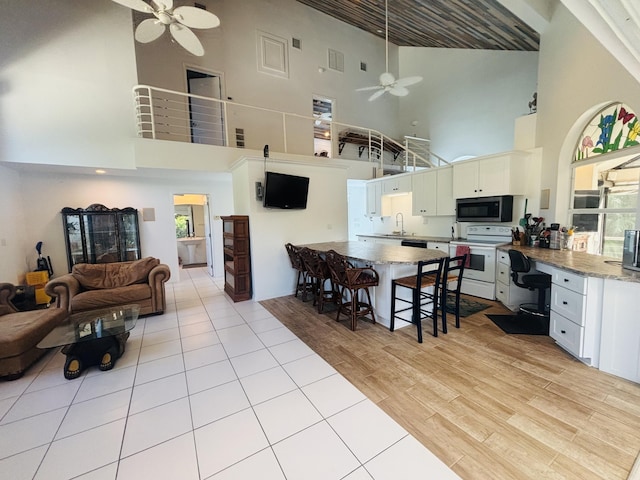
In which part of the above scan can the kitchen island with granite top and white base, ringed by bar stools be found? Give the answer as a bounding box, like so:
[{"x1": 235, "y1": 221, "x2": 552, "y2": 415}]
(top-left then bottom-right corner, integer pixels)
[{"x1": 301, "y1": 242, "x2": 448, "y2": 328}]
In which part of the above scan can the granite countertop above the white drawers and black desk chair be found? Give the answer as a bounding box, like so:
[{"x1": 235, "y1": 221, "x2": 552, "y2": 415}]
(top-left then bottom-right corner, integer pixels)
[{"x1": 498, "y1": 245, "x2": 640, "y2": 283}]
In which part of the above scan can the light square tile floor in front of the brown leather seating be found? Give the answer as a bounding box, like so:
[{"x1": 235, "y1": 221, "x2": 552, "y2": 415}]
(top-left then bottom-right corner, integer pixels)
[{"x1": 0, "y1": 269, "x2": 458, "y2": 480}]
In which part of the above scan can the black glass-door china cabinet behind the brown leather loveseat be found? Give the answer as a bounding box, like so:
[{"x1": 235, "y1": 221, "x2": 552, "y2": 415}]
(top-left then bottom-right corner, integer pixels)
[{"x1": 62, "y1": 203, "x2": 141, "y2": 271}]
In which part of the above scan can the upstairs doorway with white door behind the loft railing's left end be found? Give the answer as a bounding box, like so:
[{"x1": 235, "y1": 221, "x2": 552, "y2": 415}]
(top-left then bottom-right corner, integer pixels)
[{"x1": 186, "y1": 68, "x2": 225, "y2": 146}]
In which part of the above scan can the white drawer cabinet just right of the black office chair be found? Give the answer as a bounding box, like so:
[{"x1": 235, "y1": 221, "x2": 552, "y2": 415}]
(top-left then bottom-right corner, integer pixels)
[{"x1": 549, "y1": 268, "x2": 603, "y2": 367}]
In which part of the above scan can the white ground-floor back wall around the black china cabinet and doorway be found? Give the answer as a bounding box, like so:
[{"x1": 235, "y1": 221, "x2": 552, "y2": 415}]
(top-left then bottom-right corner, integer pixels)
[{"x1": 10, "y1": 172, "x2": 233, "y2": 280}]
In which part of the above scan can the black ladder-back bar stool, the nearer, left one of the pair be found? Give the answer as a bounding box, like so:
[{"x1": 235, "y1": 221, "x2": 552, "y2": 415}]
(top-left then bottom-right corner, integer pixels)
[{"x1": 389, "y1": 257, "x2": 447, "y2": 343}]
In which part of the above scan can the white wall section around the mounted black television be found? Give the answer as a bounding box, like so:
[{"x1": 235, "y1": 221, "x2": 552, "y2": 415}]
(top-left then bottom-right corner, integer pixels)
[{"x1": 233, "y1": 159, "x2": 348, "y2": 300}]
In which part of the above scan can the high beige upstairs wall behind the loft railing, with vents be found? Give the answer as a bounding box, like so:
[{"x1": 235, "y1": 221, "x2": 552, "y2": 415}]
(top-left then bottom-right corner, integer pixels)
[{"x1": 135, "y1": 0, "x2": 398, "y2": 139}]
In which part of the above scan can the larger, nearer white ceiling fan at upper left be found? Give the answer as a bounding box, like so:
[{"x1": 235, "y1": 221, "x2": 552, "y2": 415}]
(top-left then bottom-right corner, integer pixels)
[{"x1": 113, "y1": 0, "x2": 220, "y2": 57}]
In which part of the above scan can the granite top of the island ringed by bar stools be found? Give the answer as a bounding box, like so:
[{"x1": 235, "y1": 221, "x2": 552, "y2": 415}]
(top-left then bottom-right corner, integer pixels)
[{"x1": 300, "y1": 242, "x2": 448, "y2": 265}]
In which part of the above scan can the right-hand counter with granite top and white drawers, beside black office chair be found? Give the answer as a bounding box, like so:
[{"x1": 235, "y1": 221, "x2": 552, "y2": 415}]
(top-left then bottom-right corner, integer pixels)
[{"x1": 498, "y1": 245, "x2": 640, "y2": 382}]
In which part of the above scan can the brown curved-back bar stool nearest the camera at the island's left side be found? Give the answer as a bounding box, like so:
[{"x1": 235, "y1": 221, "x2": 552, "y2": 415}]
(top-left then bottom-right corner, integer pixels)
[{"x1": 325, "y1": 250, "x2": 379, "y2": 330}]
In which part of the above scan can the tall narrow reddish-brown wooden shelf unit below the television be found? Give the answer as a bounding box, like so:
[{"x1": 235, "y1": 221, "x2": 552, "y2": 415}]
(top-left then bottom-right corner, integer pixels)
[{"x1": 221, "y1": 215, "x2": 252, "y2": 302}]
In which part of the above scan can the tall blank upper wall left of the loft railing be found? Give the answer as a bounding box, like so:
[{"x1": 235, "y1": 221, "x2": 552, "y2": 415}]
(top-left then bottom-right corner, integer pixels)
[{"x1": 0, "y1": 0, "x2": 137, "y2": 168}]
